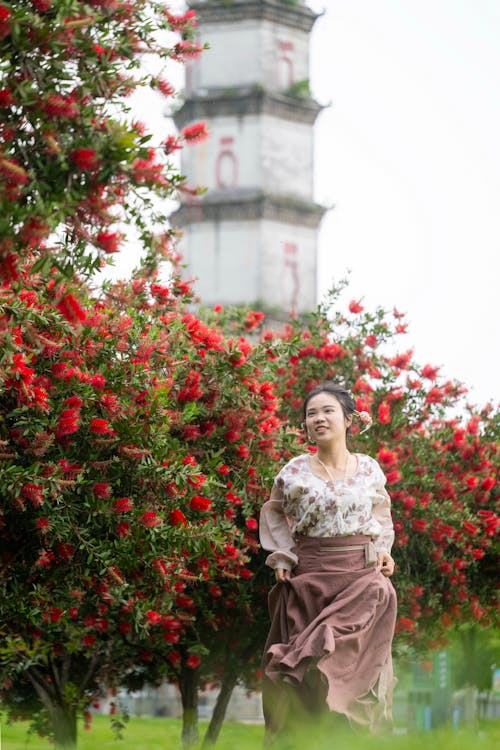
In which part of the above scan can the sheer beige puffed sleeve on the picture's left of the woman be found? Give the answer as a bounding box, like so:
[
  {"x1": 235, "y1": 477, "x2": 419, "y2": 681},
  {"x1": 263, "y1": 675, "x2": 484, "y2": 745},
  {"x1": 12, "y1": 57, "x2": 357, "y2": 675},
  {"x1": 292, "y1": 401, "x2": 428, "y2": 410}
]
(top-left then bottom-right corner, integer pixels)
[{"x1": 259, "y1": 480, "x2": 298, "y2": 570}]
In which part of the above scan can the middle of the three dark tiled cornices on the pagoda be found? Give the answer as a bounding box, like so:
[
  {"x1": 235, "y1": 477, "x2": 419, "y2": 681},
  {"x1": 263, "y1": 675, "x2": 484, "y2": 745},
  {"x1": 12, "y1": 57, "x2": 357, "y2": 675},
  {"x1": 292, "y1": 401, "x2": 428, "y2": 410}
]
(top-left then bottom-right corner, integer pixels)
[{"x1": 174, "y1": 86, "x2": 323, "y2": 128}]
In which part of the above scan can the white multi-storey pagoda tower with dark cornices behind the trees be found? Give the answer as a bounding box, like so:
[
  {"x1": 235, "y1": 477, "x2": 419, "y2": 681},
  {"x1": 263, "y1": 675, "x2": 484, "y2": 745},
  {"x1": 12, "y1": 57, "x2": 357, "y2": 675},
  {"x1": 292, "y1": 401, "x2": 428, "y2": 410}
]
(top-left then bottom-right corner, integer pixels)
[{"x1": 172, "y1": 0, "x2": 324, "y2": 317}]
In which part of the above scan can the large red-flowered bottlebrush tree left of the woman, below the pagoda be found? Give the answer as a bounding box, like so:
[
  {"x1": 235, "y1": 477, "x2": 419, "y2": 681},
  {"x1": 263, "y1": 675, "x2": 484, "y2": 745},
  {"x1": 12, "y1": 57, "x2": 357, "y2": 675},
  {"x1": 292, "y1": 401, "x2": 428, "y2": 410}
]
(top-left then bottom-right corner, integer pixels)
[{"x1": 0, "y1": 267, "x2": 296, "y2": 747}]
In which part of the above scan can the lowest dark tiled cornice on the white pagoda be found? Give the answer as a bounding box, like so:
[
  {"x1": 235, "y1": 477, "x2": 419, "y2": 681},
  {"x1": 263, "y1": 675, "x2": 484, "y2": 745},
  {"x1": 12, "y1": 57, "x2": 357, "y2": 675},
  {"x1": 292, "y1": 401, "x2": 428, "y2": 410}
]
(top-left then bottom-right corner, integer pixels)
[{"x1": 170, "y1": 189, "x2": 328, "y2": 229}]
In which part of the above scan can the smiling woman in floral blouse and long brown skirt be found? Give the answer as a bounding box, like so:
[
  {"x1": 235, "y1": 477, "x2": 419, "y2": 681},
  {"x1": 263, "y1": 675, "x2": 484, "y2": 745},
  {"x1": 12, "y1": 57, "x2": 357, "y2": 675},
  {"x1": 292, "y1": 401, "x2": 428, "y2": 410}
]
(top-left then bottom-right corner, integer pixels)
[{"x1": 260, "y1": 383, "x2": 396, "y2": 739}]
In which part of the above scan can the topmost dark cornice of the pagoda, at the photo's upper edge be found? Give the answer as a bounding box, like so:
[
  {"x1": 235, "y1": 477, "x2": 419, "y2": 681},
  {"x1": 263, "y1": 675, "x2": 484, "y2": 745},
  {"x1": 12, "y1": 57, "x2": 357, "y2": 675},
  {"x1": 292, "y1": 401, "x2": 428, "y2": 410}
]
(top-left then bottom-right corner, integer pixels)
[{"x1": 189, "y1": 0, "x2": 318, "y2": 33}]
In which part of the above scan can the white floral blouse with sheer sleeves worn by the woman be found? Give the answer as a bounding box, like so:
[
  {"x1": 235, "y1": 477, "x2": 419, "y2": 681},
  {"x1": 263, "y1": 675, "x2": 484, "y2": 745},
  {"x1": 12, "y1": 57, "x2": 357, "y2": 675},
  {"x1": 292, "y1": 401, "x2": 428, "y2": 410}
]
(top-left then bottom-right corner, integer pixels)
[{"x1": 260, "y1": 453, "x2": 394, "y2": 570}]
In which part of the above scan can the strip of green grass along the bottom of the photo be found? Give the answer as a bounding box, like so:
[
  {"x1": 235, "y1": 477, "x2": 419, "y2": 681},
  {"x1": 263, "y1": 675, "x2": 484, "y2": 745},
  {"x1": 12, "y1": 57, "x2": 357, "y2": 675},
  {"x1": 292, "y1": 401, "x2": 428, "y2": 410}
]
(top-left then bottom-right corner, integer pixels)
[{"x1": 1, "y1": 716, "x2": 500, "y2": 750}]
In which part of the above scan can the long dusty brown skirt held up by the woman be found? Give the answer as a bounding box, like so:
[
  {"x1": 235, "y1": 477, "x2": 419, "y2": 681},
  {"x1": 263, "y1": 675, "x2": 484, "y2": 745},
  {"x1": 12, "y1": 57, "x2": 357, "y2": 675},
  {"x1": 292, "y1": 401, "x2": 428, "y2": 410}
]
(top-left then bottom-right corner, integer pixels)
[{"x1": 263, "y1": 536, "x2": 396, "y2": 732}]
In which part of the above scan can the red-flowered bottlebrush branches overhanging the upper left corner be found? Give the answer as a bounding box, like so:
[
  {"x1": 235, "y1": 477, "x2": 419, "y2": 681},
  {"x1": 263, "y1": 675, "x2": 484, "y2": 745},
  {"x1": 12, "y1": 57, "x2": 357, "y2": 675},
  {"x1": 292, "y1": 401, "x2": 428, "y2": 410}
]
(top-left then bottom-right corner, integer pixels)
[{"x1": 0, "y1": 0, "x2": 205, "y2": 284}]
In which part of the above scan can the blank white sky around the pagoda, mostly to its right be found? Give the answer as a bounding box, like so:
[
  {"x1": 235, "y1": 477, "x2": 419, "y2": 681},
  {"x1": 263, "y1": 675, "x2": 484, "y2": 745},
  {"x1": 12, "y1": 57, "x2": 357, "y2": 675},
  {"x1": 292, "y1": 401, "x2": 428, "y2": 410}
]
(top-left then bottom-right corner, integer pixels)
[{"x1": 122, "y1": 0, "x2": 500, "y2": 404}]
